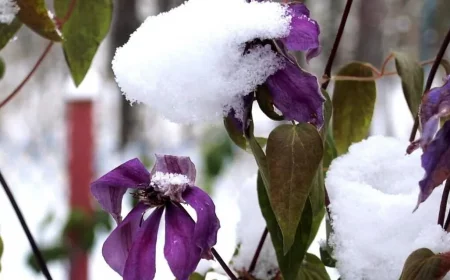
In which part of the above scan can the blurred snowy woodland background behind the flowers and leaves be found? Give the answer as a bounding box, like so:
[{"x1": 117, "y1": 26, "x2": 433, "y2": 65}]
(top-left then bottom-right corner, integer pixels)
[{"x1": 0, "y1": 0, "x2": 450, "y2": 280}]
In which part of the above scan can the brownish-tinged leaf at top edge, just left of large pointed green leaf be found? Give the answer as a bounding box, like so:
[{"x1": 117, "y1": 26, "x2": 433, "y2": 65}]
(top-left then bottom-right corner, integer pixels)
[{"x1": 16, "y1": 0, "x2": 62, "y2": 42}]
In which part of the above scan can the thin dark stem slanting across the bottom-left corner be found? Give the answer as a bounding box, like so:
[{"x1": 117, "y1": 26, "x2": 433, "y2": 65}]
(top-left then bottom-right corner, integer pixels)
[{"x1": 0, "y1": 171, "x2": 52, "y2": 280}]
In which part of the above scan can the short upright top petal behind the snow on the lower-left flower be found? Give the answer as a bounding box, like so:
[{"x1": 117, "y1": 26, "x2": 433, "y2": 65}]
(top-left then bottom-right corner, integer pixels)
[{"x1": 151, "y1": 154, "x2": 196, "y2": 184}]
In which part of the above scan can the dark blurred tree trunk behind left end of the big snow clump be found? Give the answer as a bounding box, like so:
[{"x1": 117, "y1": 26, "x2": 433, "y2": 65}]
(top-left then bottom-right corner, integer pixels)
[{"x1": 110, "y1": 0, "x2": 140, "y2": 148}]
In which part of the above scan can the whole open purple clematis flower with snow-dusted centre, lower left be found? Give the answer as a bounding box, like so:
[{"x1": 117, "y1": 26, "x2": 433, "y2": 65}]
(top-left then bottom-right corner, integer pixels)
[{"x1": 91, "y1": 155, "x2": 220, "y2": 280}]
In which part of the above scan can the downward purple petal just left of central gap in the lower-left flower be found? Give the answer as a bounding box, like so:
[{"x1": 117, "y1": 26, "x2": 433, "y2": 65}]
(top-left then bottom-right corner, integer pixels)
[{"x1": 123, "y1": 207, "x2": 164, "y2": 280}]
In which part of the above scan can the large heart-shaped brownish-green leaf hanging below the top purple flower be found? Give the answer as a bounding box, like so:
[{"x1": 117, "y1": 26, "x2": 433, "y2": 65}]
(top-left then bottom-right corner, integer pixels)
[{"x1": 266, "y1": 123, "x2": 323, "y2": 253}]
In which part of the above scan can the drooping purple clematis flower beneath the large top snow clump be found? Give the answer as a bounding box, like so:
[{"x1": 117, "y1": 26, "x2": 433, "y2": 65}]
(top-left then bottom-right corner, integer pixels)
[{"x1": 228, "y1": 3, "x2": 325, "y2": 131}]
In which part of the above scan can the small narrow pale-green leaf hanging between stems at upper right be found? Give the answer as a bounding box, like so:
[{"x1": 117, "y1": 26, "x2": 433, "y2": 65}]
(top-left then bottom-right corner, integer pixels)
[{"x1": 394, "y1": 52, "x2": 424, "y2": 117}]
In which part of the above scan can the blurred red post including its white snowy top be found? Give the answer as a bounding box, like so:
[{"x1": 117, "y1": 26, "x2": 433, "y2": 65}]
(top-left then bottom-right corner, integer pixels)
[{"x1": 66, "y1": 73, "x2": 99, "y2": 280}]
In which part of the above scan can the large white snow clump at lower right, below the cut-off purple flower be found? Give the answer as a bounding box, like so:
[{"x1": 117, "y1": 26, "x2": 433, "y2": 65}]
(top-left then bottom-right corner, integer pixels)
[{"x1": 326, "y1": 136, "x2": 450, "y2": 280}]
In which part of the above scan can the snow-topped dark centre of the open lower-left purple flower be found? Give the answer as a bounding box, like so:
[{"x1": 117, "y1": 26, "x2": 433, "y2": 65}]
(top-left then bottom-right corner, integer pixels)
[{"x1": 133, "y1": 172, "x2": 191, "y2": 207}]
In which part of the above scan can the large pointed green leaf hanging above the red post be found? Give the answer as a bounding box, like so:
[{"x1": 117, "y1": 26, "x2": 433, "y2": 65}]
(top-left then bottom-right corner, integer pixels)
[{"x1": 55, "y1": 0, "x2": 113, "y2": 86}]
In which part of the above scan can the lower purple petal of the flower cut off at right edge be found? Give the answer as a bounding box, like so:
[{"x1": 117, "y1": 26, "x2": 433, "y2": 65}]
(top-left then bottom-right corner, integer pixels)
[{"x1": 419, "y1": 121, "x2": 450, "y2": 207}]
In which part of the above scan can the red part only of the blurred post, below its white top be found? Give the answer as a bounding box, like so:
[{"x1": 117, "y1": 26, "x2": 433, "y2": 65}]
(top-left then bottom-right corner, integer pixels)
[{"x1": 67, "y1": 98, "x2": 94, "y2": 280}]
